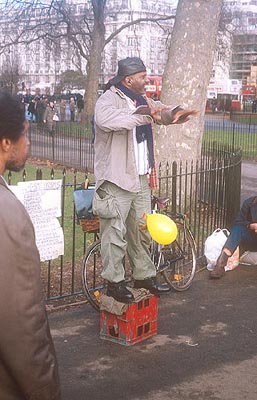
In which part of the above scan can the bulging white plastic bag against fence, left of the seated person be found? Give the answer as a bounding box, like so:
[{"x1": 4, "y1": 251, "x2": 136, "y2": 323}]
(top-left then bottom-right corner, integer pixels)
[{"x1": 204, "y1": 228, "x2": 229, "y2": 271}]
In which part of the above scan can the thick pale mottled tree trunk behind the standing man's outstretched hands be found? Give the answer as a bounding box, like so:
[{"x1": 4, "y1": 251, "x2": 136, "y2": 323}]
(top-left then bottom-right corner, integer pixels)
[{"x1": 155, "y1": 0, "x2": 222, "y2": 163}]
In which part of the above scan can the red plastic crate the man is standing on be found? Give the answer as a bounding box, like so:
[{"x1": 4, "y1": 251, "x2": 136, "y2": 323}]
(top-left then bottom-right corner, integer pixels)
[{"x1": 100, "y1": 296, "x2": 158, "y2": 346}]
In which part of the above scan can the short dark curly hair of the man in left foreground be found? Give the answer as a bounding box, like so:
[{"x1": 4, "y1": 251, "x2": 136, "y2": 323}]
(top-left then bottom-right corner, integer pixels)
[{"x1": 0, "y1": 92, "x2": 25, "y2": 142}]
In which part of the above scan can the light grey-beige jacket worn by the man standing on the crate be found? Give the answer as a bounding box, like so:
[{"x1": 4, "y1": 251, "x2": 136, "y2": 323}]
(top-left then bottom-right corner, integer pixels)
[{"x1": 94, "y1": 86, "x2": 177, "y2": 192}]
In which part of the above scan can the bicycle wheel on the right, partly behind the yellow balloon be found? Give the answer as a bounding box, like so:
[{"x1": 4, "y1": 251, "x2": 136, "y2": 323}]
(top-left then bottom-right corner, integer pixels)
[{"x1": 161, "y1": 221, "x2": 196, "y2": 291}]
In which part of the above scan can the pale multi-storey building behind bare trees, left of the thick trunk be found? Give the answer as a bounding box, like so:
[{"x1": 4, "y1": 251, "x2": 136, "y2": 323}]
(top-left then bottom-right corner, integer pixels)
[{"x1": 0, "y1": 0, "x2": 177, "y2": 94}]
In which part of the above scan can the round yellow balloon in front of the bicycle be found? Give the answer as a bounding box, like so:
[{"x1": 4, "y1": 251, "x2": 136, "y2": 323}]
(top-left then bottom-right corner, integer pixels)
[{"x1": 146, "y1": 214, "x2": 178, "y2": 244}]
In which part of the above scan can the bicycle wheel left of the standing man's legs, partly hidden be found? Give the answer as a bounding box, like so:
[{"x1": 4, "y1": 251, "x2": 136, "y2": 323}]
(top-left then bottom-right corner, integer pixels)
[{"x1": 82, "y1": 240, "x2": 104, "y2": 311}]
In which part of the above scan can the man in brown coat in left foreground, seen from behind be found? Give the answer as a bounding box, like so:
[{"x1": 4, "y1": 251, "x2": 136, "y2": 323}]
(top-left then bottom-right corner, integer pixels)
[{"x1": 0, "y1": 92, "x2": 61, "y2": 400}]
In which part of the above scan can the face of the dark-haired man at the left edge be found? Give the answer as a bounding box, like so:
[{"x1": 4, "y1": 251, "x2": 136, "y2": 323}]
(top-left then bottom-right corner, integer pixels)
[{"x1": 5, "y1": 121, "x2": 29, "y2": 172}]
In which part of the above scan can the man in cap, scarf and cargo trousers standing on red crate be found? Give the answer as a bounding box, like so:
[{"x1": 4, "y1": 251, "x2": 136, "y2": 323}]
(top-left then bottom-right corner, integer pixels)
[{"x1": 93, "y1": 57, "x2": 196, "y2": 303}]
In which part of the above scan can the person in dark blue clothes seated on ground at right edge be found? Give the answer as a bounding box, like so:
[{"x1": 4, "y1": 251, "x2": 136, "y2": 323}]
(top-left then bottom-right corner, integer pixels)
[{"x1": 210, "y1": 196, "x2": 257, "y2": 279}]
